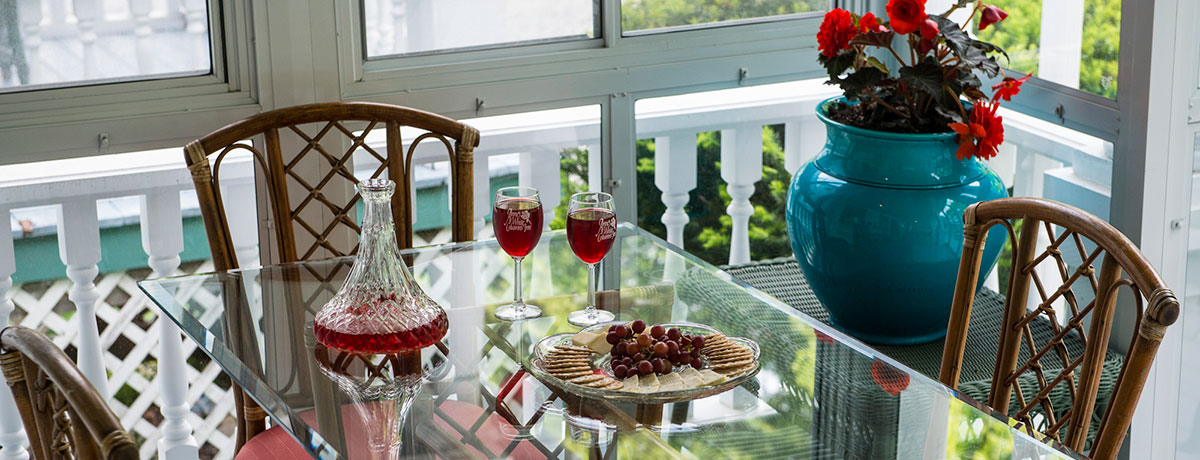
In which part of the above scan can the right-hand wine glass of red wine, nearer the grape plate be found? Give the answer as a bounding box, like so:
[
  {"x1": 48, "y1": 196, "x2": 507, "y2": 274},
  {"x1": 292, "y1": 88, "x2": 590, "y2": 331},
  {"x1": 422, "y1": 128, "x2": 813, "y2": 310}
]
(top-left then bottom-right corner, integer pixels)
[{"x1": 566, "y1": 192, "x2": 617, "y2": 327}]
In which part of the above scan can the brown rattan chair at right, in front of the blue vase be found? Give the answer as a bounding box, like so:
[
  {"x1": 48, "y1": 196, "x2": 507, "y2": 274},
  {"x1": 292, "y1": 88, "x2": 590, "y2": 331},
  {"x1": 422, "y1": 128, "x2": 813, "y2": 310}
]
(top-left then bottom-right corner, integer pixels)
[{"x1": 940, "y1": 198, "x2": 1180, "y2": 459}]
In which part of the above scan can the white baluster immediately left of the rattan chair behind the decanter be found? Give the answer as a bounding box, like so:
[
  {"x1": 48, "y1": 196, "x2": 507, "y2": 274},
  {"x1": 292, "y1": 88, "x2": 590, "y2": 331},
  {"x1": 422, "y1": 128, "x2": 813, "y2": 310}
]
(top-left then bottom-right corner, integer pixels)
[{"x1": 142, "y1": 191, "x2": 200, "y2": 460}]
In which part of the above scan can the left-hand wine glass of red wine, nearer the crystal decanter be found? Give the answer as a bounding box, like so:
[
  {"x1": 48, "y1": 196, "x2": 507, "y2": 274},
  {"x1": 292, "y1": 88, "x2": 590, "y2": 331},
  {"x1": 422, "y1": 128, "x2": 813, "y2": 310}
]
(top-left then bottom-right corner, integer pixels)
[{"x1": 492, "y1": 187, "x2": 542, "y2": 321}]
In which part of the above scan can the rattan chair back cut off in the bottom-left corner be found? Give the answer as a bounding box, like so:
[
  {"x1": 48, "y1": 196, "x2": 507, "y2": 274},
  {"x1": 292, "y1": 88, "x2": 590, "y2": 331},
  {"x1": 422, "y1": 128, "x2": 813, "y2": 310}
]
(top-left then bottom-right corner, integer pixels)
[{"x1": 0, "y1": 325, "x2": 138, "y2": 460}]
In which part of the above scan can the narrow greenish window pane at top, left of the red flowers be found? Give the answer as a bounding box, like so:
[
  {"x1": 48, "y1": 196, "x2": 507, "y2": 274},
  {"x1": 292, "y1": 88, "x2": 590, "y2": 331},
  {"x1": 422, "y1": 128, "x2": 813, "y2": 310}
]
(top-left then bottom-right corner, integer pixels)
[{"x1": 620, "y1": 0, "x2": 830, "y2": 32}]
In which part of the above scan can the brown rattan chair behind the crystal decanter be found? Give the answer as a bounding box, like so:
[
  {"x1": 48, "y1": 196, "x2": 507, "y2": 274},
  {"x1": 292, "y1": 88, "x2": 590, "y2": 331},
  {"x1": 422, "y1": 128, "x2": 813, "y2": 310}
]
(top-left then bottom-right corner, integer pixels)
[{"x1": 184, "y1": 102, "x2": 479, "y2": 449}]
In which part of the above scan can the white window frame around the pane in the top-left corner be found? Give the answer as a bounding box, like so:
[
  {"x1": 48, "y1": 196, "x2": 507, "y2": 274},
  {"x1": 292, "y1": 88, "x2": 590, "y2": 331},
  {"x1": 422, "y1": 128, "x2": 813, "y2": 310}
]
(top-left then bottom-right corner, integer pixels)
[{"x1": 0, "y1": 0, "x2": 260, "y2": 165}]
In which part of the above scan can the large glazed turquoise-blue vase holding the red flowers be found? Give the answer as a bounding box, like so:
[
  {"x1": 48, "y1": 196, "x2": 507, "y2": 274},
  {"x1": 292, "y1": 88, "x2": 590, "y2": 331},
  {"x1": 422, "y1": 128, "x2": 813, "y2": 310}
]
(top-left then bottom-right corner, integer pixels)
[{"x1": 787, "y1": 97, "x2": 1008, "y2": 345}]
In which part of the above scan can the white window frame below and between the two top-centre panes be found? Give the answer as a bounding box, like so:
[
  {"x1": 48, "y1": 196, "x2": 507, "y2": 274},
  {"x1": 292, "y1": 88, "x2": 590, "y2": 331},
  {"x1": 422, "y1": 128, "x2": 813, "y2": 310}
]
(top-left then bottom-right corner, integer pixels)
[{"x1": 334, "y1": 0, "x2": 844, "y2": 221}]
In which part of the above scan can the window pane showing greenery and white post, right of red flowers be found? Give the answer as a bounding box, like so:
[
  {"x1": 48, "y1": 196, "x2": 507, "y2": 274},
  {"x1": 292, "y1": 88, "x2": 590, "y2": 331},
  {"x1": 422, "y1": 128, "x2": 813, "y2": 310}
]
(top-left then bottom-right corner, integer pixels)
[{"x1": 979, "y1": 0, "x2": 1121, "y2": 98}]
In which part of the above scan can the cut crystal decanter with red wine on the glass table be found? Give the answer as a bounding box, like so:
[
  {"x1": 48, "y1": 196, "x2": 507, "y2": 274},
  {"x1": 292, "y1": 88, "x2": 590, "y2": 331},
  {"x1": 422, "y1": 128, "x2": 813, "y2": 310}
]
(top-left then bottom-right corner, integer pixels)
[{"x1": 313, "y1": 179, "x2": 449, "y2": 353}]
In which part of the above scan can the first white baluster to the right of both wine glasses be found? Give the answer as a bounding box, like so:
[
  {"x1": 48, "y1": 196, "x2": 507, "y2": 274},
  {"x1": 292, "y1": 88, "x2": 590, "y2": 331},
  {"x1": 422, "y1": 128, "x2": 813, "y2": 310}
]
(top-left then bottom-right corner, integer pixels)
[{"x1": 654, "y1": 132, "x2": 696, "y2": 247}]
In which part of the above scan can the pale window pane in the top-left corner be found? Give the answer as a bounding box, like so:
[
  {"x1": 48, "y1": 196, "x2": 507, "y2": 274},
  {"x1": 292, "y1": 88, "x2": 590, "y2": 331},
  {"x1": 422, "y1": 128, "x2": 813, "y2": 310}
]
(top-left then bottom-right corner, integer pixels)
[{"x1": 0, "y1": 0, "x2": 212, "y2": 92}]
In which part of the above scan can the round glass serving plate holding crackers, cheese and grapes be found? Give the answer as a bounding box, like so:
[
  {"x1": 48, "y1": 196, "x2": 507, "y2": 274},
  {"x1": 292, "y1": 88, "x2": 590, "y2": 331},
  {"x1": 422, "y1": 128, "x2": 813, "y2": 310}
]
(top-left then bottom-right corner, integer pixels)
[{"x1": 526, "y1": 321, "x2": 762, "y2": 404}]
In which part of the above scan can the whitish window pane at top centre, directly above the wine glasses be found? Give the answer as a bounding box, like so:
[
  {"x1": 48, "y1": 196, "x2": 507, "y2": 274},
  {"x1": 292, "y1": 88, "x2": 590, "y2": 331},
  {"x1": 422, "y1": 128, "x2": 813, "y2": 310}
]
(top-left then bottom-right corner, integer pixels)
[{"x1": 362, "y1": 0, "x2": 600, "y2": 58}]
